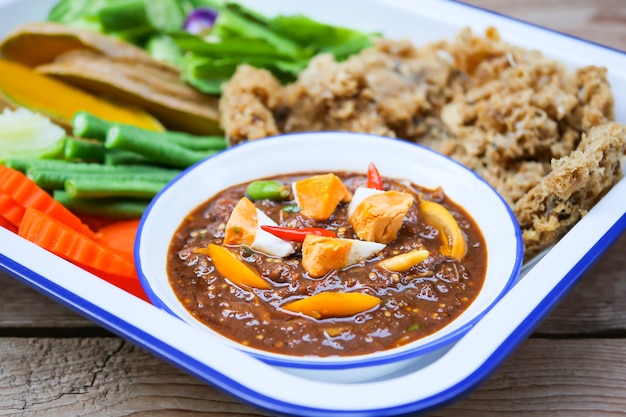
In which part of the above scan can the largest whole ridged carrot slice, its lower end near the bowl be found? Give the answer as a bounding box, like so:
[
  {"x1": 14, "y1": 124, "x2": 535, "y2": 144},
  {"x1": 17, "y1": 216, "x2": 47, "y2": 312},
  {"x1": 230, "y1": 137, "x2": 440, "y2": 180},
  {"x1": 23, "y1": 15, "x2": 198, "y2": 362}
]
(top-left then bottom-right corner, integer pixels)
[{"x1": 18, "y1": 207, "x2": 136, "y2": 278}]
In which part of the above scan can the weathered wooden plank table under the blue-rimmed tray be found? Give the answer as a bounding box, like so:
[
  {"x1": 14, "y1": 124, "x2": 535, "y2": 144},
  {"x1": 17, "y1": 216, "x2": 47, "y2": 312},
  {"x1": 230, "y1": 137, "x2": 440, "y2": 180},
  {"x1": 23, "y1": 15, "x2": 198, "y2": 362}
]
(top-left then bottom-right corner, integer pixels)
[{"x1": 0, "y1": 0, "x2": 626, "y2": 417}]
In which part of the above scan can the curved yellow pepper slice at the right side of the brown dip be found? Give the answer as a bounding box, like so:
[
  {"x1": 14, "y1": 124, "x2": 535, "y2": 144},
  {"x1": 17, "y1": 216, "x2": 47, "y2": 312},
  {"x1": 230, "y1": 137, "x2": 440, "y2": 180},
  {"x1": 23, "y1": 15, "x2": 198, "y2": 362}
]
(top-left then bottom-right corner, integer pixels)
[{"x1": 420, "y1": 199, "x2": 467, "y2": 260}]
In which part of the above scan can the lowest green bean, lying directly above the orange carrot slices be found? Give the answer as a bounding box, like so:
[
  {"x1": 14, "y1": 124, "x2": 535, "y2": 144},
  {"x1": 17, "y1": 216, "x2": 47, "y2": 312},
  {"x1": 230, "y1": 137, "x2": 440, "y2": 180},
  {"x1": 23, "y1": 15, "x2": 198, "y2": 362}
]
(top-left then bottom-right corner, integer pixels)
[{"x1": 53, "y1": 190, "x2": 150, "y2": 219}]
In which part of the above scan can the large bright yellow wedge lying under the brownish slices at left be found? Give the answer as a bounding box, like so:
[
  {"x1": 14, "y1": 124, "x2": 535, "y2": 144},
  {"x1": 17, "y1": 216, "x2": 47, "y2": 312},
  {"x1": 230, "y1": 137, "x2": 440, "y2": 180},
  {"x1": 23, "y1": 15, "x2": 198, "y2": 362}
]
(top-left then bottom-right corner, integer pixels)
[{"x1": 0, "y1": 59, "x2": 163, "y2": 130}]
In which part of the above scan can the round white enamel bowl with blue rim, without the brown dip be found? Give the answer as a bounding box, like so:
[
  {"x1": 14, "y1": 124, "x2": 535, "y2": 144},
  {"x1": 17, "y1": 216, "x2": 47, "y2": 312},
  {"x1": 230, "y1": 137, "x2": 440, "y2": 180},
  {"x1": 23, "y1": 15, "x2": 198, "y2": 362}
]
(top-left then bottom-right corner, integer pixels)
[{"x1": 135, "y1": 132, "x2": 523, "y2": 382}]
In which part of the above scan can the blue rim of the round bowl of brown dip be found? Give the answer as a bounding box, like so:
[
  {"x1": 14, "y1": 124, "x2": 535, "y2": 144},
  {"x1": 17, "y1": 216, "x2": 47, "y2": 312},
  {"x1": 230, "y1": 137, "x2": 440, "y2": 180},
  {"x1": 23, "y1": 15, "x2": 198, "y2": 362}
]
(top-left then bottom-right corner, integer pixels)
[{"x1": 134, "y1": 131, "x2": 524, "y2": 370}]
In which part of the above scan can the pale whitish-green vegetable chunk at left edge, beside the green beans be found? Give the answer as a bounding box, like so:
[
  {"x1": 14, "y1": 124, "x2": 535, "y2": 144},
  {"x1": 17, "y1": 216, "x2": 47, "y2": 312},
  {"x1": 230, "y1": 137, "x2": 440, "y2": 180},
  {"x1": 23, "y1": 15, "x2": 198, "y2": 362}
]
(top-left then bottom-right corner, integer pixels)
[{"x1": 0, "y1": 107, "x2": 65, "y2": 161}]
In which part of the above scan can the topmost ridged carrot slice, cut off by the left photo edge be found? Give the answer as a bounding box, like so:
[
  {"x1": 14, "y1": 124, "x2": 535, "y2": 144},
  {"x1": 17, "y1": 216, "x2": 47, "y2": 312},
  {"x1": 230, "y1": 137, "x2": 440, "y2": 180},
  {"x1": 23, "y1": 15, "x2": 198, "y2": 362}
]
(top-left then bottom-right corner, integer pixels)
[{"x1": 0, "y1": 165, "x2": 95, "y2": 238}]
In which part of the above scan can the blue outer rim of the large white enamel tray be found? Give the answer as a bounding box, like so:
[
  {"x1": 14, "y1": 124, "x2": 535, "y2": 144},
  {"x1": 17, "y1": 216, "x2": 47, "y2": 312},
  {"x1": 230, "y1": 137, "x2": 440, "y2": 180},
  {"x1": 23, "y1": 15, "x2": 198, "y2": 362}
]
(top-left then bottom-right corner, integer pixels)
[{"x1": 0, "y1": 0, "x2": 626, "y2": 417}]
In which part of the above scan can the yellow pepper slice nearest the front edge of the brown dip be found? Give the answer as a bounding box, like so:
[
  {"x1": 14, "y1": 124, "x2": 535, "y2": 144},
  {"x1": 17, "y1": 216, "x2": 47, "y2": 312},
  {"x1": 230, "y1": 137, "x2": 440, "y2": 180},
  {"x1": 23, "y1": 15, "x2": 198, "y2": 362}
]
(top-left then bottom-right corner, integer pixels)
[{"x1": 283, "y1": 292, "x2": 380, "y2": 319}]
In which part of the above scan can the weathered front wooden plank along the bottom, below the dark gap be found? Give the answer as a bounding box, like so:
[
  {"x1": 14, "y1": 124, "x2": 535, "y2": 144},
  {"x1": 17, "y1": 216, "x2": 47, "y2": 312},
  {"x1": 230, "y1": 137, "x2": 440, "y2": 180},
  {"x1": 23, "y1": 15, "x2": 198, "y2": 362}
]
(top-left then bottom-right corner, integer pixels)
[{"x1": 0, "y1": 338, "x2": 626, "y2": 417}]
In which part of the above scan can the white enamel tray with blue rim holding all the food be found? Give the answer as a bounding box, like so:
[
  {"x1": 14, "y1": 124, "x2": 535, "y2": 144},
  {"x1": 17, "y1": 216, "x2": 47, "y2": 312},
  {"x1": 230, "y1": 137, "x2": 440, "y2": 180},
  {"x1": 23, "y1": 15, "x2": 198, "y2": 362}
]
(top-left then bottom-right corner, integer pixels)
[{"x1": 0, "y1": 0, "x2": 626, "y2": 417}]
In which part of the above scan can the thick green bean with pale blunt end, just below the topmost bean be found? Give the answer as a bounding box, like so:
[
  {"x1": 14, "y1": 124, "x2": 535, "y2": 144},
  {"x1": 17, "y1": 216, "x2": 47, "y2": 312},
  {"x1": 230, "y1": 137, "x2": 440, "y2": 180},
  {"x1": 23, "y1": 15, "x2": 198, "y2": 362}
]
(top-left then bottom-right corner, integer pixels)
[{"x1": 104, "y1": 125, "x2": 219, "y2": 168}]
